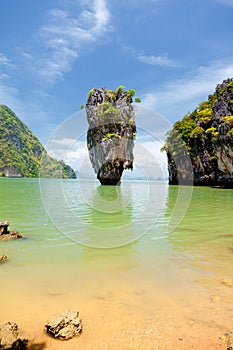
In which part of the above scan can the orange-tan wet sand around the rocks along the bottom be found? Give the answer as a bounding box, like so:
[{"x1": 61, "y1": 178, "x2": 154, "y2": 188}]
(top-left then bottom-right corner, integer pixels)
[{"x1": 0, "y1": 268, "x2": 233, "y2": 350}]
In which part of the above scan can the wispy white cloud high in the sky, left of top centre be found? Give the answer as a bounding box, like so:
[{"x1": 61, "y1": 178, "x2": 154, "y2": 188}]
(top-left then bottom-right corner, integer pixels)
[{"x1": 39, "y1": 0, "x2": 110, "y2": 83}]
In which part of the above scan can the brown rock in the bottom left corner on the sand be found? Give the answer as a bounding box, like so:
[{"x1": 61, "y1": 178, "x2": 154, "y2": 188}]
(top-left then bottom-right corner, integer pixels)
[{"x1": 0, "y1": 322, "x2": 29, "y2": 350}]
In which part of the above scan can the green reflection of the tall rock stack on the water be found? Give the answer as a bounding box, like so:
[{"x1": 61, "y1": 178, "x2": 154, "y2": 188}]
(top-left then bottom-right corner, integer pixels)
[{"x1": 80, "y1": 186, "x2": 135, "y2": 248}]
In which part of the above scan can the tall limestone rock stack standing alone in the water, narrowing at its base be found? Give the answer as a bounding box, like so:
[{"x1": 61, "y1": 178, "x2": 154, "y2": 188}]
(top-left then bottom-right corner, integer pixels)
[{"x1": 86, "y1": 88, "x2": 136, "y2": 185}]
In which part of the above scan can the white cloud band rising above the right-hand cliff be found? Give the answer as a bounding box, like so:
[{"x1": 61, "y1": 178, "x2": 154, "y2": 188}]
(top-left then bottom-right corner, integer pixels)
[{"x1": 142, "y1": 62, "x2": 233, "y2": 117}]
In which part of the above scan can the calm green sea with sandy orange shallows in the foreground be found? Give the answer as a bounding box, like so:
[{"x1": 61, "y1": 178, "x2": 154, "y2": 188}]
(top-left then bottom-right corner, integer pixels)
[{"x1": 0, "y1": 178, "x2": 233, "y2": 349}]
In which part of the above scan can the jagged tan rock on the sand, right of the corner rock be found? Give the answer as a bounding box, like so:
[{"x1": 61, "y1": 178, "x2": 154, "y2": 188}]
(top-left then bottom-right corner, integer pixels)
[{"x1": 45, "y1": 310, "x2": 82, "y2": 340}]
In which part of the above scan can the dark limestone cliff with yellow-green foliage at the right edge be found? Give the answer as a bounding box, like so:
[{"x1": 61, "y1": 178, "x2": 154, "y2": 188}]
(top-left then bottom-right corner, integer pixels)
[{"x1": 164, "y1": 79, "x2": 233, "y2": 188}]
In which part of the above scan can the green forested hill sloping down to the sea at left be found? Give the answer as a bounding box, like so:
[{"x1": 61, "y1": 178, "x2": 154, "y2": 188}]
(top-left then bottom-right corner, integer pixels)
[{"x1": 0, "y1": 105, "x2": 76, "y2": 178}]
